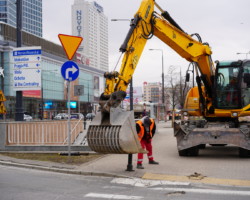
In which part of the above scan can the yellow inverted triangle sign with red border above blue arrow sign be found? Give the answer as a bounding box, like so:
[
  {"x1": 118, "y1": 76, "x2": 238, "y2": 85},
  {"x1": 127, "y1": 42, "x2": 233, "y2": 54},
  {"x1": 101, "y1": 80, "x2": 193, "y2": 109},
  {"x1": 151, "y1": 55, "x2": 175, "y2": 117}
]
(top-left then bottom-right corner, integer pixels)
[{"x1": 58, "y1": 34, "x2": 83, "y2": 60}]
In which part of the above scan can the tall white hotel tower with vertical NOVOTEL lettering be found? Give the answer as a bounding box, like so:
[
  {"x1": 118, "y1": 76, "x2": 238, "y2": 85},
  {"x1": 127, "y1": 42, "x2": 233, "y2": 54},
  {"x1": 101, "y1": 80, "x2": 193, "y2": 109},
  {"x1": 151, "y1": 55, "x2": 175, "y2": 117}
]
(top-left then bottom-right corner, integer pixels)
[{"x1": 72, "y1": 0, "x2": 108, "y2": 71}]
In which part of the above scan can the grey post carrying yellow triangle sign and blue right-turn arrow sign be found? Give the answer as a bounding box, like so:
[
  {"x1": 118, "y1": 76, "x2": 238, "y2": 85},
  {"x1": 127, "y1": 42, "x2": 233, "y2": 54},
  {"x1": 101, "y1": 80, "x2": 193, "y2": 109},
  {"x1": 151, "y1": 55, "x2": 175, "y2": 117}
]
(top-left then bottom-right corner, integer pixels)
[{"x1": 58, "y1": 34, "x2": 82, "y2": 157}]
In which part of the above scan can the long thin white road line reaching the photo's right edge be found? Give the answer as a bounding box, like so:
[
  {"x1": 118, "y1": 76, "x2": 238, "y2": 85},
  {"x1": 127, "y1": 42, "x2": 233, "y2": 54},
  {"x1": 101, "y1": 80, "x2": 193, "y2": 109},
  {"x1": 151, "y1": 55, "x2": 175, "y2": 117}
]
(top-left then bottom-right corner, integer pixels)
[{"x1": 150, "y1": 188, "x2": 250, "y2": 196}]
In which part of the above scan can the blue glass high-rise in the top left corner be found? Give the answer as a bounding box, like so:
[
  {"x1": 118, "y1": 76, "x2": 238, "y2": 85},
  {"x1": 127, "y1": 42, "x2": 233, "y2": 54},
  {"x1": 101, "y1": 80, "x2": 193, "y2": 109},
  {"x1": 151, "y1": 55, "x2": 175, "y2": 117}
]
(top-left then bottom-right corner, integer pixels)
[{"x1": 0, "y1": 0, "x2": 43, "y2": 37}]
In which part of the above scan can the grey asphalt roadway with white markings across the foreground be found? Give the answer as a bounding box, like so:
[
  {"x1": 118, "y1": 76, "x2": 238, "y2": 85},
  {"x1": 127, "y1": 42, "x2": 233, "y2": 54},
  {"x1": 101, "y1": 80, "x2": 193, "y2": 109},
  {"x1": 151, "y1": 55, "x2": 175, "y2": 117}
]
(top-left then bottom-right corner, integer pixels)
[{"x1": 0, "y1": 166, "x2": 250, "y2": 200}]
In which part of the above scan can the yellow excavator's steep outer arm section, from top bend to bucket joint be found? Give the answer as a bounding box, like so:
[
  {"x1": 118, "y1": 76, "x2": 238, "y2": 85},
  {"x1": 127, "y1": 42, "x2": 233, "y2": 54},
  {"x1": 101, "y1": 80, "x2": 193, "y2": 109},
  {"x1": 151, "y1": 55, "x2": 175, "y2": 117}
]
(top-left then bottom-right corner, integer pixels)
[{"x1": 100, "y1": 1, "x2": 154, "y2": 112}]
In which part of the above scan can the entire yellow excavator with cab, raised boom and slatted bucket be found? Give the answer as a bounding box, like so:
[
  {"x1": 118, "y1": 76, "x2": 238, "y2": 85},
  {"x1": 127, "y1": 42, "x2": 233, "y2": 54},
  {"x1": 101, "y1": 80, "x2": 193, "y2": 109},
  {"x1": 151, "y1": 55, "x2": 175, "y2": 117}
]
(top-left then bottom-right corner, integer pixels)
[{"x1": 87, "y1": 0, "x2": 250, "y2": 157}]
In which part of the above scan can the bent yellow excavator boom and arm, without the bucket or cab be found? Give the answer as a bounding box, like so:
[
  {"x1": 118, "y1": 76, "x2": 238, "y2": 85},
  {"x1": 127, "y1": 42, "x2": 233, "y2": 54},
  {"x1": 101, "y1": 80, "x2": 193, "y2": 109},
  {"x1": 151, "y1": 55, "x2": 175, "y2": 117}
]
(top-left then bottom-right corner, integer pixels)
[{"x1": 100, "y1": 0, "x2": 215, "y2": 112}]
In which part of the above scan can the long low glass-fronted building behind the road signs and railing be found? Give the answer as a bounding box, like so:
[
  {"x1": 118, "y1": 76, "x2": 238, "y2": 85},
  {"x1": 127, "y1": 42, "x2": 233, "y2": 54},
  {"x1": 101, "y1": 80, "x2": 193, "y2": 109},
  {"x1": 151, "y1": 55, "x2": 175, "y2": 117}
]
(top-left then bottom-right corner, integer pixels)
[{"x1": 0, "y1": 23, "x2": 104, "y2": 119}]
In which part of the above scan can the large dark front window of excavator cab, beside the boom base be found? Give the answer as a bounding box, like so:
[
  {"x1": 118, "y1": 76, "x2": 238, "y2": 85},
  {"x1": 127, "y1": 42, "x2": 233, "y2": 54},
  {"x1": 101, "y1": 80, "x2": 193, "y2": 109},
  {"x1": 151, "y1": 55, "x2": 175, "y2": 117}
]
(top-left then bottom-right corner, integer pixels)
[{"x1": 215, "y1": 64, "x2": 241, "y2": 109}]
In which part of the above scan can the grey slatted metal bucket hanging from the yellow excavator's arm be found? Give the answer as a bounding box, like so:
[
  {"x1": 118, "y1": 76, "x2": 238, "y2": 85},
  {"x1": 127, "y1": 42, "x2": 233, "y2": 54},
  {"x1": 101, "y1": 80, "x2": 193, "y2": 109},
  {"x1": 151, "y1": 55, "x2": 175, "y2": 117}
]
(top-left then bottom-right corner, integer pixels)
[{"x1": 87, "y1": 107, "x2": 146, "y2": 154}]
